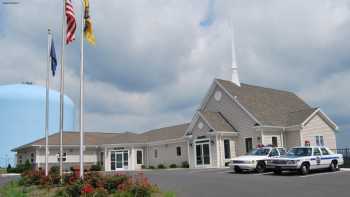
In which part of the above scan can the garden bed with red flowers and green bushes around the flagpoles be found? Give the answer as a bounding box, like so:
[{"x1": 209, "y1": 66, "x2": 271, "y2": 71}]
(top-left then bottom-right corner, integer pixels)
[{"x1": 0, "y1": 167, "x2": 175, "y2": 197}]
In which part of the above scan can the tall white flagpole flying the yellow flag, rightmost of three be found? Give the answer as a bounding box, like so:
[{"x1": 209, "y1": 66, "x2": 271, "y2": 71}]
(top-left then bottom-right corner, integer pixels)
[{"x1": 80, "y1": 0, "x2": 85, "y2": 179}]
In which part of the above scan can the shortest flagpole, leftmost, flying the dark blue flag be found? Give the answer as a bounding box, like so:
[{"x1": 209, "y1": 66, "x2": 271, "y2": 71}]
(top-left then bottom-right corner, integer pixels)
[{"x1": 45, "y1": 29, "x2": 52, "y2": 176}]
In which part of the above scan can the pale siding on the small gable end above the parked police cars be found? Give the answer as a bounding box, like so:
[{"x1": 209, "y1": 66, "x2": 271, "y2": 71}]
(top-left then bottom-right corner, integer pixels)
[{"x1": 301, "y1": 114, "x2": 337, "y2": 149}]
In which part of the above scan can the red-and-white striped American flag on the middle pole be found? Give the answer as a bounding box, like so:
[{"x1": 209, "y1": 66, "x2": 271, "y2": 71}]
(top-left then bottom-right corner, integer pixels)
[{"x1": 66, "y1": 0, "x2": 77, "y2": 44}]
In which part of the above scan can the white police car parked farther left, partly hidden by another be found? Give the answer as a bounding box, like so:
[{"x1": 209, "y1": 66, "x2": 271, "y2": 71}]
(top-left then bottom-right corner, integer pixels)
[{"x1": 229, "y1": 147, "x2": 286, "y2": 173}]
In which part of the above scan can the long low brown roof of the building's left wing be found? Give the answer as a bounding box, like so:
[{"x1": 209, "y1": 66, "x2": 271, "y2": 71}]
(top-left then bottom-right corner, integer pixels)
[{"x1": 12, "y1": 123, "x2": 189, "y2": 151}]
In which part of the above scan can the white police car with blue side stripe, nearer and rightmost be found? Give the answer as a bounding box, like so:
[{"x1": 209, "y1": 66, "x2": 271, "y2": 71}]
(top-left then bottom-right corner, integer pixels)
[{"x1": 267, "y1": 146, "x2": 344, "y2": 175}]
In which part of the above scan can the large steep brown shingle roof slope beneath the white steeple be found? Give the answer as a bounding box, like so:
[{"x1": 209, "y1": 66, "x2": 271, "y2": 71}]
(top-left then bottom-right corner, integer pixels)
[{"x1": 216, "y1": 79, "x2": 314, "y2": 126}]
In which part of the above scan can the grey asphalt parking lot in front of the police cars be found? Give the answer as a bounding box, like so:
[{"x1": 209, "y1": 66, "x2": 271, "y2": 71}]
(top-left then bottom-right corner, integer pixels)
[{"x1": 131, "y1": 169, "x2": 350, "y2": 197}]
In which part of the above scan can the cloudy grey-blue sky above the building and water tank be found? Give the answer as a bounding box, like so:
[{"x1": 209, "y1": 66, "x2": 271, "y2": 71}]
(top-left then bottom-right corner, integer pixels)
[{"x1": 0, "y1": 0, "x2": 350, "y2": 162}]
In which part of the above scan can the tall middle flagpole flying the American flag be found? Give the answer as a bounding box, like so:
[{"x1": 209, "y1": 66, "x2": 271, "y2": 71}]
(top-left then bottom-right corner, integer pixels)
[{"x1": 59, "y1": 0, "x2": 66, "y2": 183}]
